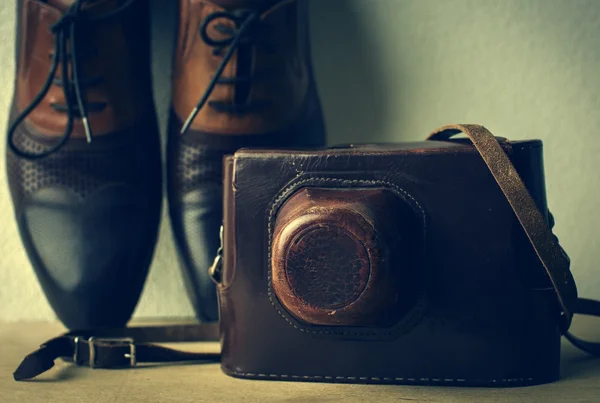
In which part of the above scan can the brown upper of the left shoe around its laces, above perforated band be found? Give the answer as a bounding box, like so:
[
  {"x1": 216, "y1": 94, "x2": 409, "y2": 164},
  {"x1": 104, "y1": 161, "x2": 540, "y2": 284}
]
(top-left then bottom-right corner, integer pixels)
[{"x1": 16, "y1": 0, "x2": 148, "y2": 138}]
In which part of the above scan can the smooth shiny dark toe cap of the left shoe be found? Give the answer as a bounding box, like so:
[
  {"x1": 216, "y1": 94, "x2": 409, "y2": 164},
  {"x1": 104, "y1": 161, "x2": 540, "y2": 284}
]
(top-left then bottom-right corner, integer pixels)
[{"x1": 18, "y1": 184, "x2": 156, "y2": 329}]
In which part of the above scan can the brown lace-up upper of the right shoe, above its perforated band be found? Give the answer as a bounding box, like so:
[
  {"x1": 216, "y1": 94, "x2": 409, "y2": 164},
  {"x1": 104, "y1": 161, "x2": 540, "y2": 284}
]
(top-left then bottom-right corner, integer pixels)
[{"x1": 172, "y1": 0, "x2": 314, "y2": 135}]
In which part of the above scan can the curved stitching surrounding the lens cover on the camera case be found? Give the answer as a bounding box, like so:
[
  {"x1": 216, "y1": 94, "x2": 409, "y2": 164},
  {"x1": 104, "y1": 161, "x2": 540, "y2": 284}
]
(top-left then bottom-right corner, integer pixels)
[{"x1": 267, "y1": 177, "x2": 427, "y2": 336}]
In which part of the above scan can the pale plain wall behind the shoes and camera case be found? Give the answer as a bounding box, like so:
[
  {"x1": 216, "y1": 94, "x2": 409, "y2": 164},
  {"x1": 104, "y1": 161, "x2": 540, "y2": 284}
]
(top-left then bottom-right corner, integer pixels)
[{"x1": 0, "y1": 0, "x2": 600, "y2": 320}]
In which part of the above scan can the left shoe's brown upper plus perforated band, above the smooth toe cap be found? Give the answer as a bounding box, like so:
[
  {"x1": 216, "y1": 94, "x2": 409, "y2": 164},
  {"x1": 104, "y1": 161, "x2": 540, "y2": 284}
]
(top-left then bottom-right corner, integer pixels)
[{"x1": 6, "y1": 0, "x2": 161, "y2": 208}]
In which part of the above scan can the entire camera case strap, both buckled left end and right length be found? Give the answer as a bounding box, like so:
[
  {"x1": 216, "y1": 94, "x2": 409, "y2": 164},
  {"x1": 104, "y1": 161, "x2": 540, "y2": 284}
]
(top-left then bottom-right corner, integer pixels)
[{"x1": 13, "y1": 125, "x2": 600, "y2": 381}]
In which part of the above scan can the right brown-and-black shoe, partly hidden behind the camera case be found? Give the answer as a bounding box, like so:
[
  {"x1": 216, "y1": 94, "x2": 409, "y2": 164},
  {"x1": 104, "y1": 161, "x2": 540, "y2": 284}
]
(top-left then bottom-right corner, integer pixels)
[{"x1": 167, "y1": 0, "x2": 325, "y2": 321}]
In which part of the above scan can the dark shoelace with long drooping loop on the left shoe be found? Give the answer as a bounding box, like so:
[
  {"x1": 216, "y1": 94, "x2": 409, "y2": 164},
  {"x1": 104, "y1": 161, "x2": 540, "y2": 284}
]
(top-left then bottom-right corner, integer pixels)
[{"x1": 7, "y1": 0, "x2": 136, "y2": 159}]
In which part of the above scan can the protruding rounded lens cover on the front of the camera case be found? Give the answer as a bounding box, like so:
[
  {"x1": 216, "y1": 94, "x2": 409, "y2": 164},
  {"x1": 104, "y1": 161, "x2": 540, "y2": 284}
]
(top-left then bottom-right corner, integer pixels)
[{"x1": 271, "y1": 187, "x2": 424, "y2": 326}]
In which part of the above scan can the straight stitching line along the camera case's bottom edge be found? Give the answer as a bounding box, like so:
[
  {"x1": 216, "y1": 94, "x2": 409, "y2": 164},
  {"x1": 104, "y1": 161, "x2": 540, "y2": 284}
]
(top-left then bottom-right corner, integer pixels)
[{"x1": 221, "y1": 366, "x2": 534, "y2": 384}]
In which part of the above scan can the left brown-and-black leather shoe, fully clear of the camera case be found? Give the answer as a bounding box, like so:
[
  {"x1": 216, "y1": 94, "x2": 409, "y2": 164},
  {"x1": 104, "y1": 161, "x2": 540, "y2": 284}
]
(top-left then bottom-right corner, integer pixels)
[{"x1": 7, "y1": 0, "x2": 161, "y2": 329}]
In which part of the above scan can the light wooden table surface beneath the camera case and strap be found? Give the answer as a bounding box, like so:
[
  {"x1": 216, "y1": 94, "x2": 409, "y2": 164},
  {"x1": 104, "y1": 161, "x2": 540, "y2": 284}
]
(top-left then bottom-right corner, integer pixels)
[{"x1": 0, "y1": 318, "x2": 600, "y2": 403}]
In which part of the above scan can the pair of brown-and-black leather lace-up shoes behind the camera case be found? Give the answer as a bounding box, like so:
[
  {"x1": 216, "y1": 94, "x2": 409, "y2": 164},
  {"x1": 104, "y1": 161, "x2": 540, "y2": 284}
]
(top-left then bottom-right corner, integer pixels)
[{"x1": 7, "y1": 0, "x2": 325, "y2": 329}]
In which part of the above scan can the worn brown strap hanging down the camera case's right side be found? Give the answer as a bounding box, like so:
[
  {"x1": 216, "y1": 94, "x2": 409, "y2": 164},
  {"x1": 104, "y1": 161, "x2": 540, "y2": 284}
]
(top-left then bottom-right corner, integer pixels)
[{"x1": 427, "y1": 124, "x2": 600, "y2": 355}]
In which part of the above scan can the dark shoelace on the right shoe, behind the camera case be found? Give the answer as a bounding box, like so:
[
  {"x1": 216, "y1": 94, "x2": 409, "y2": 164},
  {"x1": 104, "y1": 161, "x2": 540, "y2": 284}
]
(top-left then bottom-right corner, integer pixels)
[{"x1": 180, "y1": 10, "x2": 274, "y2": 134}]
